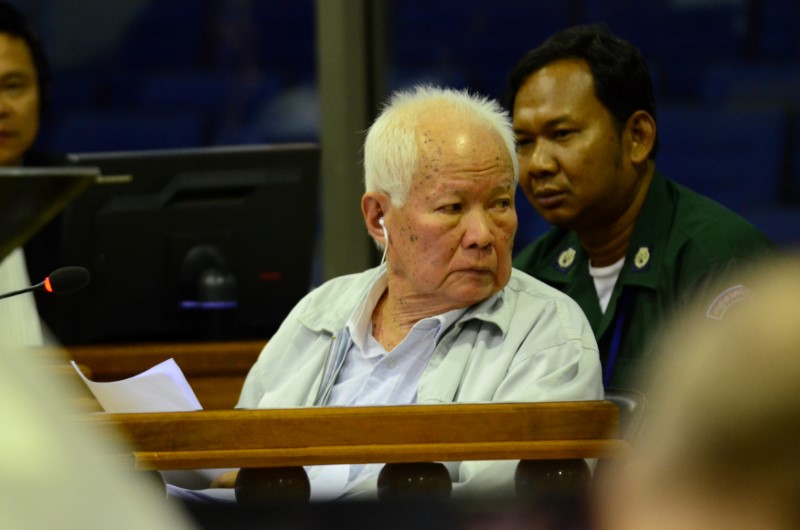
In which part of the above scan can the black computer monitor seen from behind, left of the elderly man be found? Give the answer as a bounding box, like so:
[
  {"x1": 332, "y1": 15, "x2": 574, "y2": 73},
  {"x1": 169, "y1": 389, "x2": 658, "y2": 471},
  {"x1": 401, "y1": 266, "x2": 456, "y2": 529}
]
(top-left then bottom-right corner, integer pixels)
[{"x1": 40, "y1": 144, "x2": 320, "y2": 344}]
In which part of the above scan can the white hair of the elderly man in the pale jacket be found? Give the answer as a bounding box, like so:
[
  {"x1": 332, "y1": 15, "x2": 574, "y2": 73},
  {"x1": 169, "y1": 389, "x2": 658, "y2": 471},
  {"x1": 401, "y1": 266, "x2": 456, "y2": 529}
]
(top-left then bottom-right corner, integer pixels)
[{"x1": 364, "y1": 85, "x2": 519, "y2": 207}]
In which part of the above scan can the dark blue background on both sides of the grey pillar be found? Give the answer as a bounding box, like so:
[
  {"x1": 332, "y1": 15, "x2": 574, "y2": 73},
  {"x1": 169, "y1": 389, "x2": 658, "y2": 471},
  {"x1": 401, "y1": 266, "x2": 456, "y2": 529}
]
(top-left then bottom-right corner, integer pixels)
[{"x1": 13, "y1": 0, "x2": 800, "y2": 246}]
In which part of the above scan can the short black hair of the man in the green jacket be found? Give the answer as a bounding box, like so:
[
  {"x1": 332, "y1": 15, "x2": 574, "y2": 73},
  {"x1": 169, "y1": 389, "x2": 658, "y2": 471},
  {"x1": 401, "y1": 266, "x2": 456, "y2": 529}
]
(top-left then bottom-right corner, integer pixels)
[{"x1": 506, "y1": 24, "x2": 659, "y2": 159}]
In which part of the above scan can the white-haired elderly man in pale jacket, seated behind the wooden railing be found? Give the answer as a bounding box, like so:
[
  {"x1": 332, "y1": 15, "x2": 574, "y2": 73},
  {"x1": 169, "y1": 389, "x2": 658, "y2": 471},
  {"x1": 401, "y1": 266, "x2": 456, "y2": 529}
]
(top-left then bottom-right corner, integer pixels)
[{"x1": 218, "y1": 87, "x2": 602, "y2": 497}]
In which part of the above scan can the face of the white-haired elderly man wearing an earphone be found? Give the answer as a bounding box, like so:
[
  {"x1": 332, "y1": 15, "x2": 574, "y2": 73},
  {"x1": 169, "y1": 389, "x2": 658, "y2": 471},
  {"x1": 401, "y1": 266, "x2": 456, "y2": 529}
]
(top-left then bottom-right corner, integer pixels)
[{"x1": 386, "y1": 116, "x2": 517, "y2": 308}]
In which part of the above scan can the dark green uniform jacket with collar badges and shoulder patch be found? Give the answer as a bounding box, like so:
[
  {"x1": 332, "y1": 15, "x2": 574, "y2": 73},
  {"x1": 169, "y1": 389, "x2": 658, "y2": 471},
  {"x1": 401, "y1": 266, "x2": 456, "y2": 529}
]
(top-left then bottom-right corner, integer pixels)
[{"x1": 514, "y1": 172, "x2": 775, "y2": 388}]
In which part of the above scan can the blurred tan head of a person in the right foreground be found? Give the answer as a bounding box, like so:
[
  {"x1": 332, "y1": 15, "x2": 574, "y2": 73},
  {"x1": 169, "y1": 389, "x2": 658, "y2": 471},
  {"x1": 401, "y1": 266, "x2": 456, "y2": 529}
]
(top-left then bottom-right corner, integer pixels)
[{"x1": 597, "y1": 257, "x2": 800, "y2": 530}]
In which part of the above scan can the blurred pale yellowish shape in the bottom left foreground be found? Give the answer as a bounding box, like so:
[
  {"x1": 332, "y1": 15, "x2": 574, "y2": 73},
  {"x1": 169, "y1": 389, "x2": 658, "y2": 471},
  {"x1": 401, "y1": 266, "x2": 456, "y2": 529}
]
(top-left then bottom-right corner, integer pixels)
[{"x1": 0, "y1": 323, "x2": 195, "y2": 530}]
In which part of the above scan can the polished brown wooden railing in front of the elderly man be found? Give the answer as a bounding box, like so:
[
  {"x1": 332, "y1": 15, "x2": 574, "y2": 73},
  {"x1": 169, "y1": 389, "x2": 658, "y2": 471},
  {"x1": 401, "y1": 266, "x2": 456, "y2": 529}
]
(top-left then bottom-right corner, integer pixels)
[{"x1": 83, "y1": 401, "x2": 629, "y2": 500}]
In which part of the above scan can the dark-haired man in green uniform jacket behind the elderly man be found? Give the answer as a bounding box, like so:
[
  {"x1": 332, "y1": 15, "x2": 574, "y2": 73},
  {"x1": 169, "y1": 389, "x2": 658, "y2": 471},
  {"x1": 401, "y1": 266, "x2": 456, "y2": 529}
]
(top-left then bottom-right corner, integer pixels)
[{"x1": 508, "y1": 25, "x2": 773, "y2": 387}]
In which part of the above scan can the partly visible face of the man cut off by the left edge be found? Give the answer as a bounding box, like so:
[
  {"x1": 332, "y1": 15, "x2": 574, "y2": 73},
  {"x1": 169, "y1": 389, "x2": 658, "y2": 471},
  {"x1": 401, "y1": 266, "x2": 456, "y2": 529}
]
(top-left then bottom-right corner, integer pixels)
[{"x1": 0, "y1": 33, "x2": 39, "y2": 166}]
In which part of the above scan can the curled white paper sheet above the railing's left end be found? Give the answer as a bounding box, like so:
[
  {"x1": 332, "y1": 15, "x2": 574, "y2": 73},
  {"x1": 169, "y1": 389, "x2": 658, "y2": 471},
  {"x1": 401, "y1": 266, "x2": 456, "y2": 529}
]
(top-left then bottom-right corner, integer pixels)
[{"x1": 70, "y1": 359, "x2": 203, "y2": 412}]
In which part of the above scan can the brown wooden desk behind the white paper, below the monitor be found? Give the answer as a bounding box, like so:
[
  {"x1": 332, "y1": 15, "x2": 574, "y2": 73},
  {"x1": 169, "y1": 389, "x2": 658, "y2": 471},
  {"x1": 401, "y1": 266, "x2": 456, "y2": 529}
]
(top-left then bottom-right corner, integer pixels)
[{"x1": 65, "y1": 340, "x2": 266, "y2": 410}]
